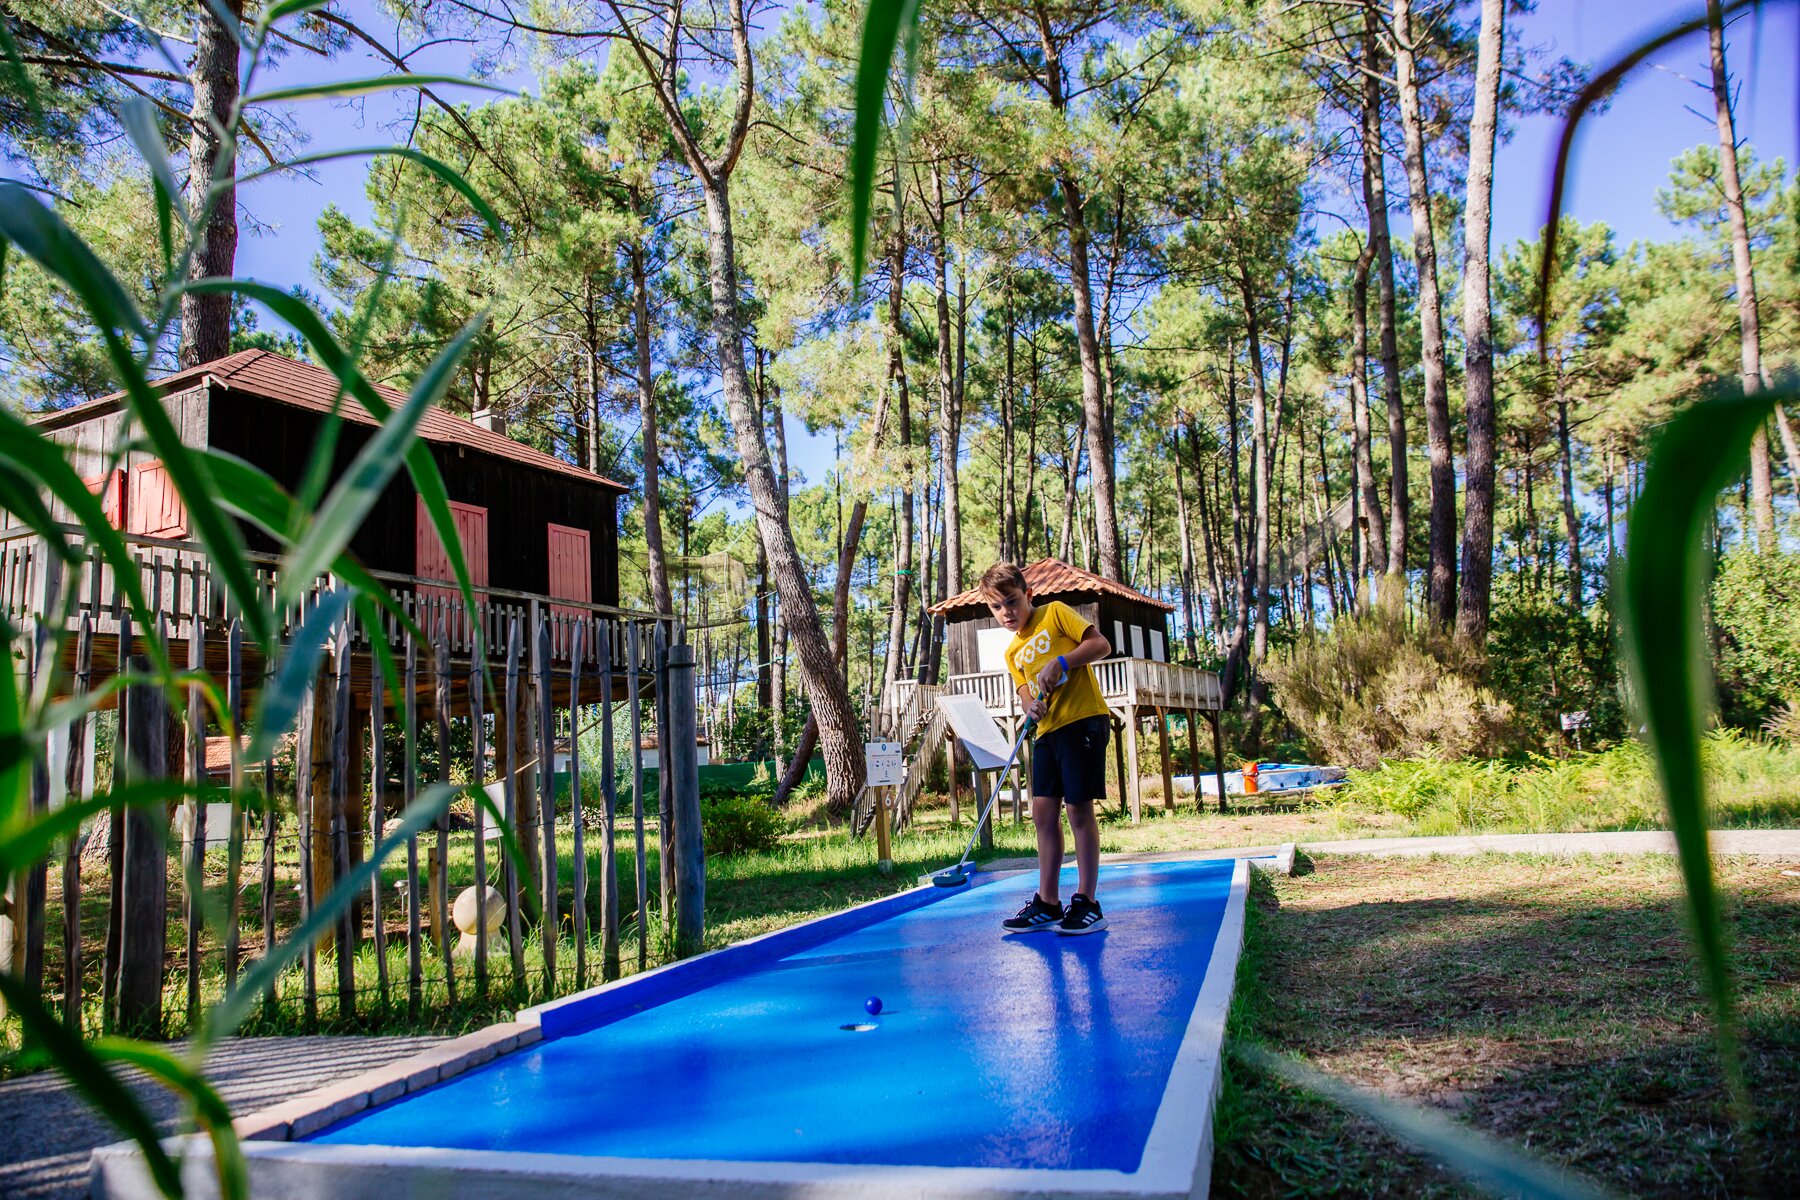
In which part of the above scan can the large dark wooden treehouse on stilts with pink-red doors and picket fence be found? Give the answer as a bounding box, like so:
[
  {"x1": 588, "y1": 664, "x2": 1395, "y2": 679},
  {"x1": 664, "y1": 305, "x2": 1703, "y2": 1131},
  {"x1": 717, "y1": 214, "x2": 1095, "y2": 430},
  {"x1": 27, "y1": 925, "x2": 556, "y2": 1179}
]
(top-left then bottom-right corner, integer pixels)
[{"x1": 0, "y1": 351, "x2": 704, "y2": 1029}]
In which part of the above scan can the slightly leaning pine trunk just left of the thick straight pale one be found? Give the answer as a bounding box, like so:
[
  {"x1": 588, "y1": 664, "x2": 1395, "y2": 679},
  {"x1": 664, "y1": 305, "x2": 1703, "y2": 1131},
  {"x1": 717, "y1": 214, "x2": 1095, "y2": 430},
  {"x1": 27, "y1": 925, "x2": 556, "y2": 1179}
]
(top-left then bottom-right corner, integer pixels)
[{"x1": 1393, "y1": 0, "x2": 1456, "y2": 628}]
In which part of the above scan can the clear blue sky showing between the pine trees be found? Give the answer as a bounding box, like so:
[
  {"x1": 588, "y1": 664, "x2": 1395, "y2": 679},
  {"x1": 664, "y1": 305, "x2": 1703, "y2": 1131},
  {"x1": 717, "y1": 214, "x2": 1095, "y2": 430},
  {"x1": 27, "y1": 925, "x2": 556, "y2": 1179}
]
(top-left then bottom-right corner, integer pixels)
[{"x1": 238, "y1": 0, "x2": 1800, "y2": 480}]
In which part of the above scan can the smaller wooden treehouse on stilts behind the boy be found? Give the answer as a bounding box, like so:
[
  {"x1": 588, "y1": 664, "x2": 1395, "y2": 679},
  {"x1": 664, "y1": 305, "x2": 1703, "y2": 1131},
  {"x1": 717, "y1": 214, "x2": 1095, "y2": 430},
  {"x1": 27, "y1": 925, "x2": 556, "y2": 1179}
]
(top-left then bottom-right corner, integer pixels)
[{"x1": 875, "y1": 558, "x2": 1224, "y2": 820}]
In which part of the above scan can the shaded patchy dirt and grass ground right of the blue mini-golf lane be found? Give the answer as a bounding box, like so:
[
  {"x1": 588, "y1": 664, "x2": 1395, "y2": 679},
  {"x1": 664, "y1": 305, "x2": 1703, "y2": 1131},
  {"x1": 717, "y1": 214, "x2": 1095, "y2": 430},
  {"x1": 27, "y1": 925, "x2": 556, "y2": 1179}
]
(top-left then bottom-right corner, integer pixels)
[{"x1": 1213, "y1": 855, "x2": 1800, "y2": 1196}]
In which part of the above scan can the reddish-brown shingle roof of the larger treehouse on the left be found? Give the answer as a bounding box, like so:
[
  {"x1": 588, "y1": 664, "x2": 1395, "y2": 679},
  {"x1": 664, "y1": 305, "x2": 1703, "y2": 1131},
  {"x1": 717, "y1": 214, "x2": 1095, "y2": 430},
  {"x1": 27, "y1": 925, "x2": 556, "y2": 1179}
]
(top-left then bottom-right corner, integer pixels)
[{"x1": 36, "y1": 351, "x2": 626, "y2": 491}]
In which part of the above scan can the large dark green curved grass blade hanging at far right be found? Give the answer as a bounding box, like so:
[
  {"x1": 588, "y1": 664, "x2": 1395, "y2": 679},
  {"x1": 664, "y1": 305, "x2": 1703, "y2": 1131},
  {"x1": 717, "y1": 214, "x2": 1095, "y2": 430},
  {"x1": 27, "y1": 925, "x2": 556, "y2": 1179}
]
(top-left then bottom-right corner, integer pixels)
[{"x1": 1618, "y1": 392, "x2": 1782, "y2": 1112}]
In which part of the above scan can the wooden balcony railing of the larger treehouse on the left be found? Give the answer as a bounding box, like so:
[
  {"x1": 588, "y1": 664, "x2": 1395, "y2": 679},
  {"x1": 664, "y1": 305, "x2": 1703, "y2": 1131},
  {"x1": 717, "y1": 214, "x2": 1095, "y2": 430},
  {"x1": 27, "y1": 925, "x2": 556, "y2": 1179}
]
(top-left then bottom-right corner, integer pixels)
[{"x1": 0, "y1": 525, "x2": 680, "y2": 667}]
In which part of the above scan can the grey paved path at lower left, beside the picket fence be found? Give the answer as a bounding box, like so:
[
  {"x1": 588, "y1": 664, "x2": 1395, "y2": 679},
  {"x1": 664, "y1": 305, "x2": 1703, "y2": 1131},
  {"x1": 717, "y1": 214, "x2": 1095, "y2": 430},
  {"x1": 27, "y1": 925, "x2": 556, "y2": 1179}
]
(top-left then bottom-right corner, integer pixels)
[{"x1": 0, "y1": 1036, "x2": 443, "y2": 1200}]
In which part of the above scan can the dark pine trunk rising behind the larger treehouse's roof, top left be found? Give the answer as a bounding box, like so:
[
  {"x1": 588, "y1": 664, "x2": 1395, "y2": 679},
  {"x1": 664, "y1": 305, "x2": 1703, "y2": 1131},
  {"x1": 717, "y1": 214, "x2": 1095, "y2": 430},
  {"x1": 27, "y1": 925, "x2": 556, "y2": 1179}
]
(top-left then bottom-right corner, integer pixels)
[{"x1": 178, "y1": 0, "x2": 243, "y2": 367}]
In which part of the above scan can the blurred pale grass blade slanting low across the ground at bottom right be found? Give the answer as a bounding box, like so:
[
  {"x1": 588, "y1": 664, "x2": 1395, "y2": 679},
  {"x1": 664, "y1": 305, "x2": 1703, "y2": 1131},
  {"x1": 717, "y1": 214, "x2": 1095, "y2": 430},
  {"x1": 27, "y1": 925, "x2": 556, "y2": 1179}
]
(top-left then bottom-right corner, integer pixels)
[{"x1": 1231, "y1": 1045, "x2": 1609, "y2": 1200}]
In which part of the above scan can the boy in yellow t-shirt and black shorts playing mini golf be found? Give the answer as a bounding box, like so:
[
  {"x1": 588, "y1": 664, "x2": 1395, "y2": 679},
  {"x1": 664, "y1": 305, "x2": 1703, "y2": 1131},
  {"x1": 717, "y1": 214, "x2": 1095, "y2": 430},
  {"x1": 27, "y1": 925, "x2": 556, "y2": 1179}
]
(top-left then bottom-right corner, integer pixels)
[{"x1": 981, "y1": 563, "x2": 1112, "y2": 934}]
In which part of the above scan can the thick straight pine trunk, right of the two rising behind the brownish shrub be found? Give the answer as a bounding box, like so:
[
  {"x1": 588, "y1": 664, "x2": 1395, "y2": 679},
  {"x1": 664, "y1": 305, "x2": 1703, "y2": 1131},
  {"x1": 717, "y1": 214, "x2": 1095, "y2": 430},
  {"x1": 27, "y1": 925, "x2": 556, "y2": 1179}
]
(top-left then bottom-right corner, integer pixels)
[{"x1": 1433, "y1": 0, "x2": 1504, "y2": 648}]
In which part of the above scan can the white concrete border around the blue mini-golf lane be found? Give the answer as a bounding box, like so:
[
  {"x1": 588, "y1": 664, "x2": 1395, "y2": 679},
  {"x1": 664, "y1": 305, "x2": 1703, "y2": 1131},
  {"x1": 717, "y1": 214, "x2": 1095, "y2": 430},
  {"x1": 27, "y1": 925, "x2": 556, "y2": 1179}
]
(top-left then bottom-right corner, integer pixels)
[{"x1": 88, "y1": 860, "x2": 1249, "y2": 1200}]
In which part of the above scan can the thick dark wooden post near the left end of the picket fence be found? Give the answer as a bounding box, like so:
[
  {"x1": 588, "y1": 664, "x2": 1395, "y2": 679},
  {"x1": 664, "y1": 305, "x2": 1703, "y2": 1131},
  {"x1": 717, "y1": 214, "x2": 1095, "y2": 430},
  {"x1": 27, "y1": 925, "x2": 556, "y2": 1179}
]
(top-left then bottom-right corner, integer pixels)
[{"x1": 117, "y1": 658, "x2": 169, "y2": 1036}]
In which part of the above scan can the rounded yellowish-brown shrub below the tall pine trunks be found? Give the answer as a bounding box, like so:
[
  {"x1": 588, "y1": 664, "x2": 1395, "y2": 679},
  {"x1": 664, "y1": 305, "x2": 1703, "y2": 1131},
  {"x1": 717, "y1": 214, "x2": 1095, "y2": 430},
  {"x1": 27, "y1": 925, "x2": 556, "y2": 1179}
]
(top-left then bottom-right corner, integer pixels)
[{"x1": 1267, "y1": 606, "x2": 1512, "y2": 768}]
